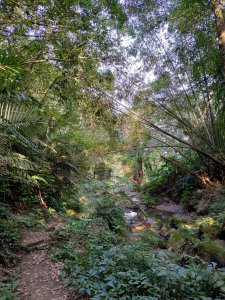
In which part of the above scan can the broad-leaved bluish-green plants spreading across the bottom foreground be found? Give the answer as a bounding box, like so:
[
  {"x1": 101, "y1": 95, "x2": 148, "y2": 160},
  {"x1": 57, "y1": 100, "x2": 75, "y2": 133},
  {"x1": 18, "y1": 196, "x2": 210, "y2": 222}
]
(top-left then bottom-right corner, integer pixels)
[{"x1": 60, "y1": 243, "x2": 225, "y2": 300}]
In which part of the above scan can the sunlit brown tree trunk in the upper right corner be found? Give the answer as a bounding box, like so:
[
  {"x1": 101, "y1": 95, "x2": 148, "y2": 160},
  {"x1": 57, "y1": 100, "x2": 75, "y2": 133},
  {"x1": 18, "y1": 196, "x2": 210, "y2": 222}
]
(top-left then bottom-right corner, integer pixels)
[{"x1": 211, "y1": 0, "x2": 225, "y2": 83}]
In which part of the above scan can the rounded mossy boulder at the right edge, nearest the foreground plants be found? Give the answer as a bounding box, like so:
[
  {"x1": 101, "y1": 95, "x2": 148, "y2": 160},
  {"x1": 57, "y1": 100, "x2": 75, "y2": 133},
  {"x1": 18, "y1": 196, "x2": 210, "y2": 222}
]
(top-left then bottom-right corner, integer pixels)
[{"x1": 197, "y1": 240, "x2": 225, "y2": 267}]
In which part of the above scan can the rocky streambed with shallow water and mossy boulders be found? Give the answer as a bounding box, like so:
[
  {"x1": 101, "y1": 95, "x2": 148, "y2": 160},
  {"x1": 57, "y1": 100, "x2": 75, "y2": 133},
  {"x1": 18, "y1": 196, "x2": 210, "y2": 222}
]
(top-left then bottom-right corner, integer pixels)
[{"x1": 118, "y1": 191, "x2": 225, "y2": 267}]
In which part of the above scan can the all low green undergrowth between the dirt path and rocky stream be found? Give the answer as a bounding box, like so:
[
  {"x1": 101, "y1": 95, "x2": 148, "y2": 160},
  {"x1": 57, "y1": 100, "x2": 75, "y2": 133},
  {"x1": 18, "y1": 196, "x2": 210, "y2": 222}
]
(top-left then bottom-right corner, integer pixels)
[{"x1": 53, "y1": 196, "x2": 225, "y2": 300}]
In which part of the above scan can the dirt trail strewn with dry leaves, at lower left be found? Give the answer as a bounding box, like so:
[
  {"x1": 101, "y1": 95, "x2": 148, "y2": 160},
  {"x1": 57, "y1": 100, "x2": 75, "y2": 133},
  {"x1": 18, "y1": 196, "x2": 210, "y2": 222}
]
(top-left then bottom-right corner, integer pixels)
[{"x1": 17, "y1": 219, "x2": 75, "y2": 300}]
